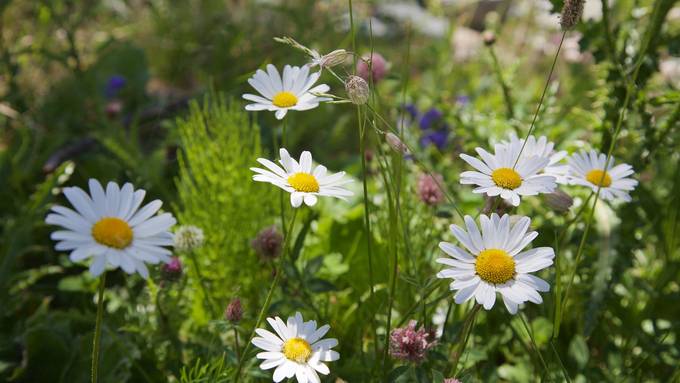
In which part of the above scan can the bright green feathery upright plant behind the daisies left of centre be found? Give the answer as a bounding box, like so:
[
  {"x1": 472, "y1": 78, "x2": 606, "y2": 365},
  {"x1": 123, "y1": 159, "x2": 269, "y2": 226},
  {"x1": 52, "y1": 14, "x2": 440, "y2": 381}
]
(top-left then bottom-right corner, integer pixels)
[{"x1": 176, "y1": 94, "x2": 278, "y2": 323}]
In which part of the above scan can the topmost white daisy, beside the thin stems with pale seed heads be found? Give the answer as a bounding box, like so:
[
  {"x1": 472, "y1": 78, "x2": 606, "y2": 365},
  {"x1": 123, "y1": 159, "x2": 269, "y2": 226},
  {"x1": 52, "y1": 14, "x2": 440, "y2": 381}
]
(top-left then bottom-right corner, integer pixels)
[{"x1": 243, "y1": 64, "x2": 330, "y2": 120}]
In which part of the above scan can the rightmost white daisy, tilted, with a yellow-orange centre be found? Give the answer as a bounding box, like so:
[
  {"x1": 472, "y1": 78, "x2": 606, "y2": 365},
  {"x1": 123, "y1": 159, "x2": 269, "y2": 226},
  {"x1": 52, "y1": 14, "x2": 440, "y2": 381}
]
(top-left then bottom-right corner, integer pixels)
[{"x1": 567, "y1": 150, "x2": 638, "y2": 202}]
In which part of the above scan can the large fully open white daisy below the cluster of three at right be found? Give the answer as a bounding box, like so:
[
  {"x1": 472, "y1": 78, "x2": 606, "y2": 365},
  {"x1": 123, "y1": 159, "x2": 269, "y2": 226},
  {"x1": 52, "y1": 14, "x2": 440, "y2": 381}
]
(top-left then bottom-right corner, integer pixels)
[{"x1": 437, "y1": 213, "x2": 555, "y2": 314}]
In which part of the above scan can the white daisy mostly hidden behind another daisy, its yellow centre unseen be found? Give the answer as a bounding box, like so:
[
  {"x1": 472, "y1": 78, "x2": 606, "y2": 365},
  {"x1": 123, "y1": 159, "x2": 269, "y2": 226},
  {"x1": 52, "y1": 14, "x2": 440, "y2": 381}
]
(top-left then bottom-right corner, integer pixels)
[{"x1": 501, "y1": 134, "x2": 569, "y2": 184}]
